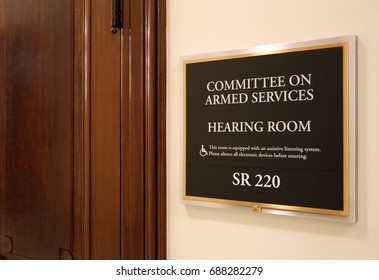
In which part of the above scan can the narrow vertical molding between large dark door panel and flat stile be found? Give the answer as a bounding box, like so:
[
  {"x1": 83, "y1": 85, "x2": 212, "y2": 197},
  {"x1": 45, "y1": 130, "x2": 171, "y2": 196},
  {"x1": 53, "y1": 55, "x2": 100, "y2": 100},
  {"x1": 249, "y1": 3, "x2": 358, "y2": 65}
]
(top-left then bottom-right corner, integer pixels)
[{"x1": 71, "y1": 0, "x2": 91, "y2": 259}]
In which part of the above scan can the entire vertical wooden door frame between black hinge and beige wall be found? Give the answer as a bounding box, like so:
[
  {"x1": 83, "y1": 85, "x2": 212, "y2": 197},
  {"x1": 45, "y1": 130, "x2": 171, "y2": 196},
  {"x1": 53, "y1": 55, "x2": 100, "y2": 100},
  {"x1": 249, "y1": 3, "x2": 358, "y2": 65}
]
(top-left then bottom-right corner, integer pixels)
[{"x1": 121, "y1": 0, "x2": 167, "y2": 259}]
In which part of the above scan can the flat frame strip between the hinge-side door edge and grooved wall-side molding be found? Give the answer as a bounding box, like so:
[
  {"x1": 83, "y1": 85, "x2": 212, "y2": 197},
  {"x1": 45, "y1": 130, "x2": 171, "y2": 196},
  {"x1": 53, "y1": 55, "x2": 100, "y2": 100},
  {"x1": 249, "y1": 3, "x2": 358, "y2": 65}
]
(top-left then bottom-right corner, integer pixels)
[{"x1": 121, "y1": 0, "x2": 145, "y2": 259}]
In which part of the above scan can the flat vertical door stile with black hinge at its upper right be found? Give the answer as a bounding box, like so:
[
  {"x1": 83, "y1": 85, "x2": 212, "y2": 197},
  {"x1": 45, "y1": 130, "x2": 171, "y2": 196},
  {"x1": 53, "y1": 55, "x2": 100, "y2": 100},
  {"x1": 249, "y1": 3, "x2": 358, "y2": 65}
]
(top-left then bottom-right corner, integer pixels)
[{"x1": 91, "y1": 0, "x2": 121, "y2": 259}]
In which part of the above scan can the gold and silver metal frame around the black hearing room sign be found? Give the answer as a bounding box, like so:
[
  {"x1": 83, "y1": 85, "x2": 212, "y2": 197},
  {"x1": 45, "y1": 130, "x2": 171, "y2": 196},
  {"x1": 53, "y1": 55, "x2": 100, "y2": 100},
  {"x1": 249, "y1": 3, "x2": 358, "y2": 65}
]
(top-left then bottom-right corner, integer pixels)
[{"x1": 181, "y1": 35, "x2": 357, "y2": 222}]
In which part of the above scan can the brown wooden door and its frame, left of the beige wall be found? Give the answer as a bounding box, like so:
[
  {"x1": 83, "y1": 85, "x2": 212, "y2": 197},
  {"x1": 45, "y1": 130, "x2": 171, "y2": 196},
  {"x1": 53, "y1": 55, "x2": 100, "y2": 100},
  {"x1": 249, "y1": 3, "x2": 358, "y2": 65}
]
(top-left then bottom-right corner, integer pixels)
[{"x1": 0, "y1": 0, "x2": 166, "y2": 259}]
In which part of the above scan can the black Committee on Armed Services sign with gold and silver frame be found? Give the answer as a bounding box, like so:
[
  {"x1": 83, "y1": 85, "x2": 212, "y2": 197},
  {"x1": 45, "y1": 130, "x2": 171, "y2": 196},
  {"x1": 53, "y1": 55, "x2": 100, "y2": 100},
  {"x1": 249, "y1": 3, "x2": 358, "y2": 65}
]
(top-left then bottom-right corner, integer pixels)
[{"x1": 182, "y1": 36, "x2": 355, "y2": 221}]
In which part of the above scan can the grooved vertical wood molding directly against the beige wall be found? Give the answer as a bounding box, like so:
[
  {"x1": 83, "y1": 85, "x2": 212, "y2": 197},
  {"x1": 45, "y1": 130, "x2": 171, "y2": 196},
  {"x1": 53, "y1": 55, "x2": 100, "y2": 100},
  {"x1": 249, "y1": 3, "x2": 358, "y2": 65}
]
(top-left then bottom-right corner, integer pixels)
[{"x1": 144, "y1": 0, "x2": 167, "y2": 259}]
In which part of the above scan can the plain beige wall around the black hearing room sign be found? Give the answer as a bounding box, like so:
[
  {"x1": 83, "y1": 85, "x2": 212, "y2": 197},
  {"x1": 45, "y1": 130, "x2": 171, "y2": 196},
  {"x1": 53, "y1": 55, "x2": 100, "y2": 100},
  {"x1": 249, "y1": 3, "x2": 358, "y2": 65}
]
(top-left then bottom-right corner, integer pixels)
[{"x1": 167, "y1": 0, "x2": 379, "y2": 259}]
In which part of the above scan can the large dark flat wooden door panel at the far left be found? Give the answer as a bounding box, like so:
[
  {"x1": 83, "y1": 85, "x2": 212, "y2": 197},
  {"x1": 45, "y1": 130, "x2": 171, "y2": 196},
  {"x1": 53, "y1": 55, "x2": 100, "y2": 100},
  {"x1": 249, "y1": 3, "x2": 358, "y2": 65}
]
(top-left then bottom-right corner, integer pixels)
[{"x1": 1, "y1": 0, "x2": 73, "y2": 259}]
